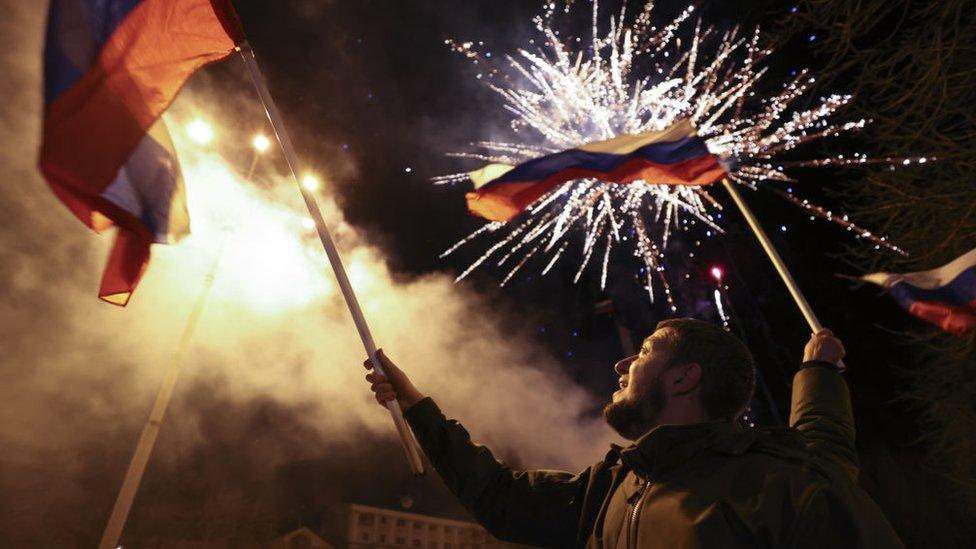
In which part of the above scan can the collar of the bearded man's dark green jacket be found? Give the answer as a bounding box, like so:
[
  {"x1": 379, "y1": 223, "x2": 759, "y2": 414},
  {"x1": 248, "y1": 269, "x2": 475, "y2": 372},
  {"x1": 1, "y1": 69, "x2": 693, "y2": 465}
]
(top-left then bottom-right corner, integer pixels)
[{"x1": 620, "y1": 421, "x2": 742, "y2": 477}]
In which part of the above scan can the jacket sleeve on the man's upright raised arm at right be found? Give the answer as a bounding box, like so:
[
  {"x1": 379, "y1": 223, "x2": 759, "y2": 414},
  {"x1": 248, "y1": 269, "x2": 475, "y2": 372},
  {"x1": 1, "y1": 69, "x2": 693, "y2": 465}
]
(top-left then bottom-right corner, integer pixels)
[{"x1": 790, "y1": 363, "x2": 858, "y2": 482}]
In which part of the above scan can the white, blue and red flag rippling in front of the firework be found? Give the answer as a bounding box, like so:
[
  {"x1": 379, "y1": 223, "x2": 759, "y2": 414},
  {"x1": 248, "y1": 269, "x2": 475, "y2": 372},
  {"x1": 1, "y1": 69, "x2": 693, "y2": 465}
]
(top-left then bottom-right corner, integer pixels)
[{"x1": 467, "y1": 119, "x2": 725, "y2": 221}]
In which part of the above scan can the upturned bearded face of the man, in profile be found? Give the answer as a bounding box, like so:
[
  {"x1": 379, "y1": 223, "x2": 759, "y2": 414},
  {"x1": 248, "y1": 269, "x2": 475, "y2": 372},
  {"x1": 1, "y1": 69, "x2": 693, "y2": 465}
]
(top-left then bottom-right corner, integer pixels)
[{"x1": 603, "y1": 328, "x2": 671, "y2": 440}]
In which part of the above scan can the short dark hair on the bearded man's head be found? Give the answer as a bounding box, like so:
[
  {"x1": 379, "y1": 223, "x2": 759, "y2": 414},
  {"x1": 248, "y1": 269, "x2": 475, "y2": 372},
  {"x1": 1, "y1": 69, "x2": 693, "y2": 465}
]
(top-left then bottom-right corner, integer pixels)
[{"x1": 657, "y1": 318, "x2": 756, "y2": 420}]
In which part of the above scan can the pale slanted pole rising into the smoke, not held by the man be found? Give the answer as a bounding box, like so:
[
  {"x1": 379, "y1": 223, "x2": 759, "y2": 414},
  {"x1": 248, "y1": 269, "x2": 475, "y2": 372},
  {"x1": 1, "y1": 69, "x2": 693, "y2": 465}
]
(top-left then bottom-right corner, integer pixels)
[{"x1": 98, "y1": 240, "x2": 226, "y2": 549}]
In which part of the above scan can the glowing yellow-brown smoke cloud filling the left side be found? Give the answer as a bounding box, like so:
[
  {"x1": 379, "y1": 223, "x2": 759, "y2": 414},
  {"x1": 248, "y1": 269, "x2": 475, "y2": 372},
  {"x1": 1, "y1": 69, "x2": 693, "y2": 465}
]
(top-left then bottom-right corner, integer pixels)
[{"x1": 0, "y1": 1, "x2": 612, "y2": 546}]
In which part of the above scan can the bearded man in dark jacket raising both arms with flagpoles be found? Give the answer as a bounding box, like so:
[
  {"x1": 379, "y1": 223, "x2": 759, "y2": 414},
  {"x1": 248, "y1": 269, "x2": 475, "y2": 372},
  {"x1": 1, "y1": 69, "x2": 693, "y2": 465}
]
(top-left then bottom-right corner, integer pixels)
[{"x1": 365, "y1": 318, "x2": 902, "y2": 549}]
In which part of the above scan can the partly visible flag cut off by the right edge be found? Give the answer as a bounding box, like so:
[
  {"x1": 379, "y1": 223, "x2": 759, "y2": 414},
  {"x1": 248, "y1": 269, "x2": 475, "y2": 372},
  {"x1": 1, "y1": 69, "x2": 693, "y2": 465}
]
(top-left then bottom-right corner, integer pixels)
[{"x1": 861, "y1": 249, "x2": 976, "y2": 336}]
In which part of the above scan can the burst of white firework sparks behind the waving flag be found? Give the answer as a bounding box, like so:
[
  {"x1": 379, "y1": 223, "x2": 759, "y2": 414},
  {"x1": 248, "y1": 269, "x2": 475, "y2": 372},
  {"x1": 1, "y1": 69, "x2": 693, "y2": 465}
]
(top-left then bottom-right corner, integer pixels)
[{"x1": 434, "y1": 0, "x2": 927, "y2": 309}]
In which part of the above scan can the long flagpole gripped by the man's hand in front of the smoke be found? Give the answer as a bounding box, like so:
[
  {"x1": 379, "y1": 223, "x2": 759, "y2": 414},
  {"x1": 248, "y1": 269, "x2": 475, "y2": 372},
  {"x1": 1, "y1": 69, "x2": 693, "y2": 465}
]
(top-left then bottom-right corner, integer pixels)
[{"x1": 238, "y1": 41, "x2": 424, "y2": 475}]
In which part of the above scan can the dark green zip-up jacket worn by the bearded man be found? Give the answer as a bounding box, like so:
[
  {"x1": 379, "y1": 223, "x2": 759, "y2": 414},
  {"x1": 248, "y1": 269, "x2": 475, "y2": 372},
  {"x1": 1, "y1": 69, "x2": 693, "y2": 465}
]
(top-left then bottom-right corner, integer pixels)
[{"x1": 406, "y1": 366, "x2": 902, "y2": 549}]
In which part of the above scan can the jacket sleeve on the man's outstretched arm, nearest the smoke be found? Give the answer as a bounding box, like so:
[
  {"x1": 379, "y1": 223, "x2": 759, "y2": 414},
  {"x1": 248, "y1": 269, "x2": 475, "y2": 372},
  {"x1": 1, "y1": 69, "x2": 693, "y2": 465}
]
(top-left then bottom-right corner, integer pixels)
[{"x1": 404, "y1": 398, "x2": 589, "y2": 547}]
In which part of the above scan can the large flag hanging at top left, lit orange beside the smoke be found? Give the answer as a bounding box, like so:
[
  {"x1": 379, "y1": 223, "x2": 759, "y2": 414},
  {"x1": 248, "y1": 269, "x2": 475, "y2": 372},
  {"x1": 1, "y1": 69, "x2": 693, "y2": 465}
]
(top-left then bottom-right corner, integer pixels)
[{"x1": 39, "y1": 0, "x2": 244, "y2": 305}]
